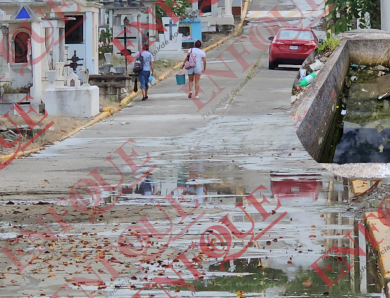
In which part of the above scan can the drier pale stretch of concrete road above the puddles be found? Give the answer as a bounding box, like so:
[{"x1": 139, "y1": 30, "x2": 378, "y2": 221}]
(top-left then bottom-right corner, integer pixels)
[{"x1": 0, "y1": 5, "x2": 319, "y2": 199}]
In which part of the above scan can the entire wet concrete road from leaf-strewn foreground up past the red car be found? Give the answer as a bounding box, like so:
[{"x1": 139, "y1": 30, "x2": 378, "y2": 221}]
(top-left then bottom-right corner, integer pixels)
[{"x1": 0, "y1": 1, "x2": 384, "y2": 298}]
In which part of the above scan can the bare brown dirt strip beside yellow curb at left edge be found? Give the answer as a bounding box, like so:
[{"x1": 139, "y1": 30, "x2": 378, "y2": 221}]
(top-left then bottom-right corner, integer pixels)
[{"x1": 0, "y1": 114, "x2": 91, "y2": 156}]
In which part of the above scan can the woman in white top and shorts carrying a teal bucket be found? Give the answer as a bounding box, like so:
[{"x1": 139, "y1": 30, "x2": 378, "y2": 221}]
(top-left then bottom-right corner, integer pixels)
[{"x1": 181, "y1": 40, "x2": 206, "y2": 99}]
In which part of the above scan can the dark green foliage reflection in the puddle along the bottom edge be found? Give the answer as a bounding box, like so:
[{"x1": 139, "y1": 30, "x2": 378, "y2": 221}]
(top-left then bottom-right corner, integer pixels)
[{"x1": 171, "y1": 257, "x2": 385, "y2": 297}]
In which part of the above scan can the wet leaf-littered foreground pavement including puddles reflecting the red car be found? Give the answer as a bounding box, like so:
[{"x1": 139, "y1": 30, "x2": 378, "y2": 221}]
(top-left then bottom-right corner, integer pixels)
[{"x1": 0, "y1": 173, "x2": 388, "y2": 297}]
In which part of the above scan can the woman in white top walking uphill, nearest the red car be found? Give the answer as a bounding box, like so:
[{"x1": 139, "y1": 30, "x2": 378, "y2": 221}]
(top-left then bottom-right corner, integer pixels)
[{"x1": 181, "y1": 40, "x2": 206, "y2": 99}]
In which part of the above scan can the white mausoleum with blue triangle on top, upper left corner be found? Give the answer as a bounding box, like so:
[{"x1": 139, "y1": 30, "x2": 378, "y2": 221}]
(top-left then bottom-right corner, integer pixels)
[{"x1": 0, "y1": 0, "x2": 101, "y2": 106}]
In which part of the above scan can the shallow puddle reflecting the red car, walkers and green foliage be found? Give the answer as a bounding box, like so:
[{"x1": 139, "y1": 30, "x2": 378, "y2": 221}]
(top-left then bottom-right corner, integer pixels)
[{"x1": 115, "y1": 171, "x2": 384, "y2": 297}]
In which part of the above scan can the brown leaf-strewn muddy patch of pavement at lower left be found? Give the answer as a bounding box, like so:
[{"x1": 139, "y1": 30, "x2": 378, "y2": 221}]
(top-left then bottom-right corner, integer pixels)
[{"x1": 0, "y1": 198, "x2": 219, "y2": 297}]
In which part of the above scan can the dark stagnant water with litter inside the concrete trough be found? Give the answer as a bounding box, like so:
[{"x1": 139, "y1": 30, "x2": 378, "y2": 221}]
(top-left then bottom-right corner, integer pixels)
[{"x1": 320, "y1": 67, "x2": 390, "y2": 164}]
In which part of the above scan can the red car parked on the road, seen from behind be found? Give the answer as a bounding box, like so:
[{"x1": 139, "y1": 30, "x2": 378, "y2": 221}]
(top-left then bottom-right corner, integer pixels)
[{"x1": 269, "y1": 28, "x2": 319, "y2": 69}]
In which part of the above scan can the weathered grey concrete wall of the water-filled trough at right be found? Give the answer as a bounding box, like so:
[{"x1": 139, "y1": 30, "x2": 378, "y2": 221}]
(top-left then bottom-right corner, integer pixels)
[{"x1": 292, "y1": 30, "x2": 390, "y2": 162}]
